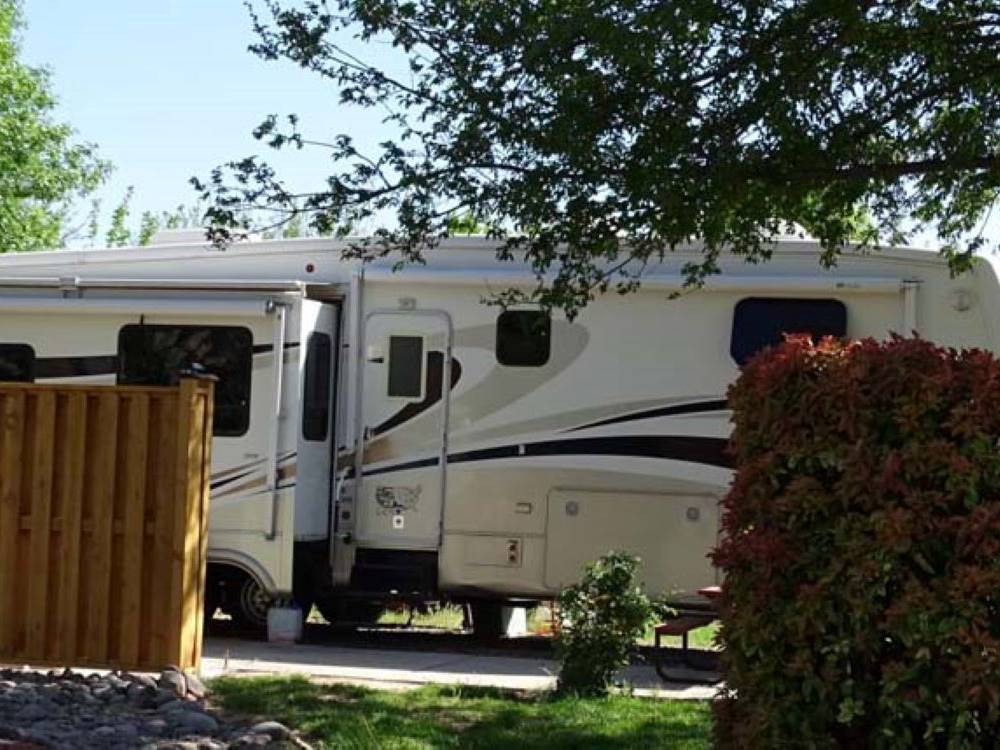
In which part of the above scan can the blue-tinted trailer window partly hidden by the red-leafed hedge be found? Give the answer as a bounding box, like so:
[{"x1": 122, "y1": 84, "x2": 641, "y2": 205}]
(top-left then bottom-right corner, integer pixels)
[{"x1": 729, "y1": 297, "x2": 847, "y2": 365}]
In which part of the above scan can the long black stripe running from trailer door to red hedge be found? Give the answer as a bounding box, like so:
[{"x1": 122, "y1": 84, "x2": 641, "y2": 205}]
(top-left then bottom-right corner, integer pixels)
[{"x1": 364, "y1": 435, "x2": 733, "y2": 476}]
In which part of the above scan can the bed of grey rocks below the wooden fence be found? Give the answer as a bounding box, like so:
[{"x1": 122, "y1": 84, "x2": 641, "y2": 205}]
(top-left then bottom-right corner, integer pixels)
[{"x1": 0, "y1": 667, "x2": 308, "y2": 750}]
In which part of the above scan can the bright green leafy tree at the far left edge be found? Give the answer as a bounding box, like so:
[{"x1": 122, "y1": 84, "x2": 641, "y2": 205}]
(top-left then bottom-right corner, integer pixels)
[{"x1": 0, "y1": 0, "x2": 109, "y2": 252}]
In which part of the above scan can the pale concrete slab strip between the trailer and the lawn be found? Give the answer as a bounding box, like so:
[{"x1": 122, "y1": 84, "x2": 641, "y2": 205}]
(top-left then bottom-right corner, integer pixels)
[{"x1": 201, "y1": 638, "x2": 716, "y2": 700}]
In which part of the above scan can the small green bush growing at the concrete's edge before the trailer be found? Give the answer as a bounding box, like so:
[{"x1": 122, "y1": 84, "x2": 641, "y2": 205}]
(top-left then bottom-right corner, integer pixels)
[{"x1": 556, "y1": 552, "x2": 659, "y2": 695}]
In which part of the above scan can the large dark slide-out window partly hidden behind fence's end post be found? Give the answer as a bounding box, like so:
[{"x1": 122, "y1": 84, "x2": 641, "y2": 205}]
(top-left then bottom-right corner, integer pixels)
[{"x1": 118, "y1": 325, "x2": 253, "y2": 437}]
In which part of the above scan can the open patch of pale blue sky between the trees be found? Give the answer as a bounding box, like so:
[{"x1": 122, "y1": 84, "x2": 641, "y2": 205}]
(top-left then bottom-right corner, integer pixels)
[{"x1": 22, "y1": 0, "x2": 390, "y2": 235}]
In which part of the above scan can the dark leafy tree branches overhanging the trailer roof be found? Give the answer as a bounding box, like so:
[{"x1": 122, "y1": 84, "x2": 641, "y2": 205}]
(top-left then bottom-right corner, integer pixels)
[{"x1": 194, "y1": 0, "x2": 1000, "y2": 314}]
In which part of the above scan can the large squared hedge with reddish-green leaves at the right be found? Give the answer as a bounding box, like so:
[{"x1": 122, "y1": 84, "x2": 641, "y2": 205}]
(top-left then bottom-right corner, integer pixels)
[{"x1": 715, "y1": 338, "x2": 1000, "y2": 750}]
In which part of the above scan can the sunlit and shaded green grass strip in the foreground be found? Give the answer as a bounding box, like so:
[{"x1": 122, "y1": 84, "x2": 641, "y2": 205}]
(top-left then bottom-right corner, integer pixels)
[{"x1": 211, "y1": 677, "x2": 711, "y2": 750}]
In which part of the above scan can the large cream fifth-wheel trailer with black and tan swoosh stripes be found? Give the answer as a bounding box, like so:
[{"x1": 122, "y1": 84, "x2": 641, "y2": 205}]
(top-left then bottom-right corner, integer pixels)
[{"x1": 0, "y1": 238, "x2": 1000, "y2": 629}]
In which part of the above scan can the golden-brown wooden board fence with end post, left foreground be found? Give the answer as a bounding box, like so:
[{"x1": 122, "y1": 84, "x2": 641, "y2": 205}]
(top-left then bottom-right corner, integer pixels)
[{"x1": 0, "y1": 379, "x2": 213, "y2": 670}]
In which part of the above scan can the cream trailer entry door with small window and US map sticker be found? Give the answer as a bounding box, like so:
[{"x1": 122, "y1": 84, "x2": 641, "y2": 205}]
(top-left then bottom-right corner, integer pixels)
[{"x1": 357, "y1": 310, "x2": 453, "y2": 550}]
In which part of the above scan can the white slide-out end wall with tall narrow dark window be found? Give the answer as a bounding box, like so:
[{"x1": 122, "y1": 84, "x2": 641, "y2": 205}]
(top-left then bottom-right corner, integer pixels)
[{"x1": 295, "y1": 300, "x2": 340, "y2": 541}]
